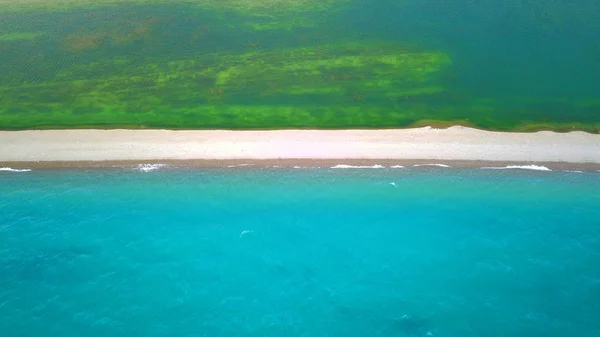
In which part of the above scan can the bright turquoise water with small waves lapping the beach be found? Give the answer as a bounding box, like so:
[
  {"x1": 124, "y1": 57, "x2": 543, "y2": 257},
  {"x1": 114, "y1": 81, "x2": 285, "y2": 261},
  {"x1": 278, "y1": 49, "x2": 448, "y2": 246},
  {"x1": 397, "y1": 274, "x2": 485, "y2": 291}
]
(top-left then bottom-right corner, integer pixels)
[{"x1": 0, "y1": 169, "x2": 600, "y2": 337}]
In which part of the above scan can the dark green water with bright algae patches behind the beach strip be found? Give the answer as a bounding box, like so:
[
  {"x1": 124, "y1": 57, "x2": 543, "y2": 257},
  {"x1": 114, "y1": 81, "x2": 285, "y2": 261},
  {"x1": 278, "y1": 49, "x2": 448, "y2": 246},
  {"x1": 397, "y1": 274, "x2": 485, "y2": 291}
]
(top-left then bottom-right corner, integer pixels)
[{"x1": 0, "y1": 0, "x2": 600, "y2": 132}]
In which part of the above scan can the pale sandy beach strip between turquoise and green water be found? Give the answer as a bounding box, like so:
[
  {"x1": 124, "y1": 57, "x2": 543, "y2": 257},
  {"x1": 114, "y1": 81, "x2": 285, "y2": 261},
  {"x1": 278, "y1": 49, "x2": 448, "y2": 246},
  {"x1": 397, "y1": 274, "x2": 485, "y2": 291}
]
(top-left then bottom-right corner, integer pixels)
[{"x1": 0, "y1": 126, "x2": 600, "y2": 171}]
